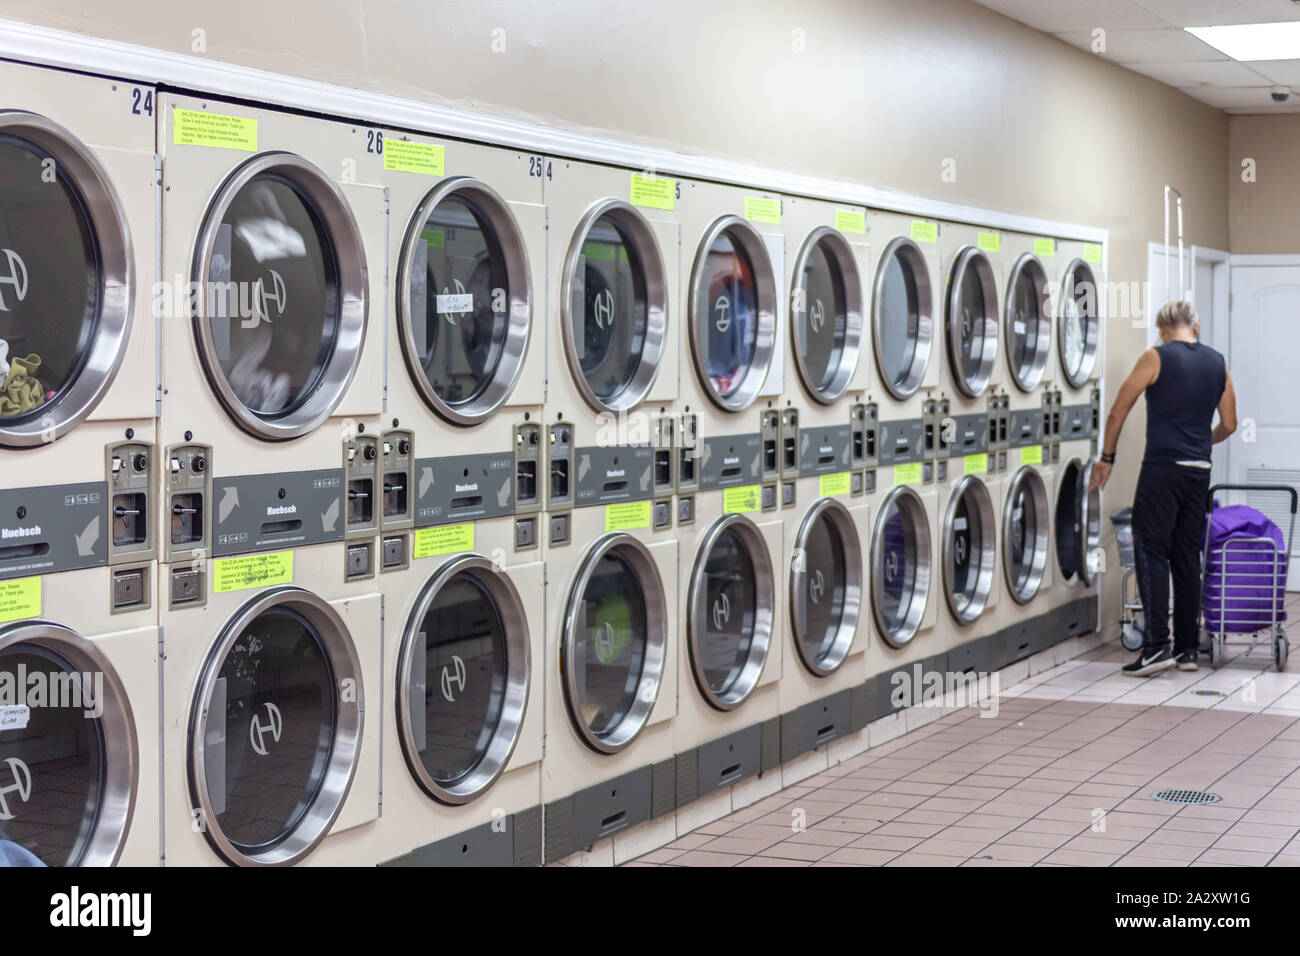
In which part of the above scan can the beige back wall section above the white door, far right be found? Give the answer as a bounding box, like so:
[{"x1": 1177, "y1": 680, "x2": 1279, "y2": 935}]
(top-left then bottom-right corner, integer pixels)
[{"x1": 1227, "y1": 114, "x2": 1300, "y2": 254}]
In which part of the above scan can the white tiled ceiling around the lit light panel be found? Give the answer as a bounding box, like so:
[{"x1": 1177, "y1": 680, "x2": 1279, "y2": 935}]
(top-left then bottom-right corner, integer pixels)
[{"x1": 976, "y1": 0, "x2": 1300, "y2": 113}]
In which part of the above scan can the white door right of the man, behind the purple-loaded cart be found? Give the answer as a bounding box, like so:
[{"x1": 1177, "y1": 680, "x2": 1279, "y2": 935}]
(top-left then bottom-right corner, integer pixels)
[{"x1": 1226, "y1": 256, "x2": 1300, "y2": 591}]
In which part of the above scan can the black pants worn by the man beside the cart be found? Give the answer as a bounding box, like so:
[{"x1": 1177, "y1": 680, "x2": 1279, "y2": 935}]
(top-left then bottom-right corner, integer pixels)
[{"x1": 1134, "y1": 462, "x2": 1210, "y2": 654}]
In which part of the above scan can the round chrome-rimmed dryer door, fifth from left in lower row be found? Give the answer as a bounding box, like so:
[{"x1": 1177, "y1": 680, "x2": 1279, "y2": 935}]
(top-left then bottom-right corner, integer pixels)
[{"x1": 689, "y1": 515, "x2": 774, "y2": 710}]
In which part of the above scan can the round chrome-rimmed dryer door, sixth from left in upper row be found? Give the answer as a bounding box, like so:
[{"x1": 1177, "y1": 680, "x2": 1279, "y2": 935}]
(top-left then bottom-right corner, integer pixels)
[{"x1": 790, "y1": 228, "x2": 862, "y2": 403}]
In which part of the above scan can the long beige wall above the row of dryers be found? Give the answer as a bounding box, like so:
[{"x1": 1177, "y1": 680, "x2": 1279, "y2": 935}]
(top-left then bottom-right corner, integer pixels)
[{"x1": 0, "y1": 0, "x2": 1227, "y2": 629}]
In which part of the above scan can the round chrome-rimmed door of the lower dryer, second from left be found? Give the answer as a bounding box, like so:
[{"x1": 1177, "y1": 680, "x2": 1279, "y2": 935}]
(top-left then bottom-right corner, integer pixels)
[{"x1": 189, "y1": 587, "x2": 364, "y2": 865}]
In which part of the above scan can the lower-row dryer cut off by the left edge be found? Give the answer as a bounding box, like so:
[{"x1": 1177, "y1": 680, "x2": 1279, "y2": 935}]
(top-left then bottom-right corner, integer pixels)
[{"x1": 0, "y1": 566, "x2": 163, "y2": 866}]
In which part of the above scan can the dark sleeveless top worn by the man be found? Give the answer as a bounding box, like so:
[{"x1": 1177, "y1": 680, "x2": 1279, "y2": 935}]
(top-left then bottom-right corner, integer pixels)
[{"x1": 1144, "y1": 342, "x2": 1227, "y2": 463}]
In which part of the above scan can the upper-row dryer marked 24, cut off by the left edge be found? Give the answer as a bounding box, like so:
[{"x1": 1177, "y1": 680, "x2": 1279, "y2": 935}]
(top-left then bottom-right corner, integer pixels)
[{"x1": 0, "y1": 62, "x2": 159, "y2": 610}]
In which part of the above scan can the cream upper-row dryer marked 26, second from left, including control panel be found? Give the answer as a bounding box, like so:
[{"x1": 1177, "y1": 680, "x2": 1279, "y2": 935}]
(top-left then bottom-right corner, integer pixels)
[{"x1": 159, "y1": 92, "x2": 387, "y2": 609}]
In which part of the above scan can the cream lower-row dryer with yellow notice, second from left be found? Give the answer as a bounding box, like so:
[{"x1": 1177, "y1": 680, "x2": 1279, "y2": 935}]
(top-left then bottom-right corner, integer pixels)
[{"x1": 161, "y1": 542, "x2": 379, "y2": 866}]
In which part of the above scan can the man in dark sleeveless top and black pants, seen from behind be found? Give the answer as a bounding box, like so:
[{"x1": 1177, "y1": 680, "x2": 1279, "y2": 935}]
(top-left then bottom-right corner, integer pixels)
[{"x1": 1092, "y1": 302, "x2": 1236, "y2": 678}]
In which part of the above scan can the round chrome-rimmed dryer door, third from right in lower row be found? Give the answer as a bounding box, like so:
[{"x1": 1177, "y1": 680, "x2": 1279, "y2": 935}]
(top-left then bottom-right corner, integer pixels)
[{"x1": 944, "y1": 475, "x2": 996, "y2": 624}]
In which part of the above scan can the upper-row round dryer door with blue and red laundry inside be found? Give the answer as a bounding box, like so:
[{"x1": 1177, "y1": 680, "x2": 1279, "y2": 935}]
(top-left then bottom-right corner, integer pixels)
[{"x1": 690, "y1": 216, "x2": 776, "y2": 411}]
